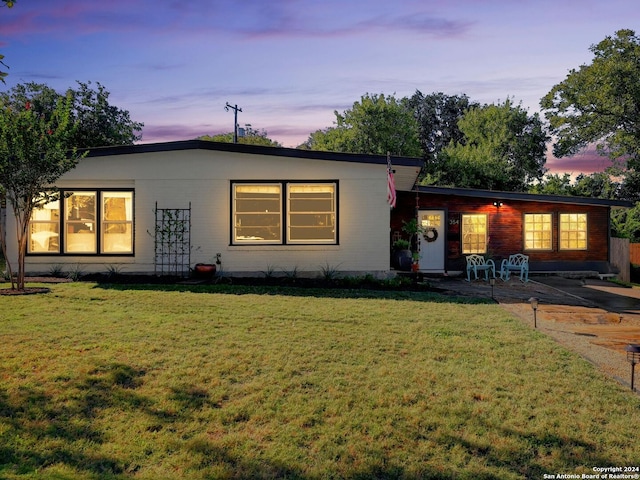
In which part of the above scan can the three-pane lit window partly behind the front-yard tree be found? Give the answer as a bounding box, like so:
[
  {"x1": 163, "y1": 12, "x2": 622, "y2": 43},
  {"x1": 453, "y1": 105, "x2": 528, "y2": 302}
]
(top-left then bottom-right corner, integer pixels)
[{"x1": 28, "y1": 190, "x2": 133, "y2": 254}]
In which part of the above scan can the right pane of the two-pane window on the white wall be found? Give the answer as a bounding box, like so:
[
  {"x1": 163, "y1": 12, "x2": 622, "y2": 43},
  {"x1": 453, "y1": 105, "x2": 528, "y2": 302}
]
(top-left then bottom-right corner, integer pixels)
[{"x1": 288, "y1": 183, "x2": 336, "y2": 243}]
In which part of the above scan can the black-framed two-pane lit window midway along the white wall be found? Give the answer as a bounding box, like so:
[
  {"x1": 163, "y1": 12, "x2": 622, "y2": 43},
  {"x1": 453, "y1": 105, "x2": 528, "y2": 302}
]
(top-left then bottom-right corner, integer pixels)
[{"x1": 231, "y1": 182, "x2": 338, "y2": 245}]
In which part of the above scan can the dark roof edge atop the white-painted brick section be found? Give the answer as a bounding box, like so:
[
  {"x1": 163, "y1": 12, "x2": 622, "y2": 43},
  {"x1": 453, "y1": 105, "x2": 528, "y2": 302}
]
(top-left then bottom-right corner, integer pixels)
[{"x1": 87, "y1": 140, "x2": 422, "y2": 167}]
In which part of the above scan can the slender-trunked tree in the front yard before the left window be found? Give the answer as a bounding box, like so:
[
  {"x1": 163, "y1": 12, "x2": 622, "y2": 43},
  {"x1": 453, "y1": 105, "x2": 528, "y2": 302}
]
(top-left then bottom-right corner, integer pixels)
[{"x1": 0, "y1": 95, "x2": 86, "y2": 290}]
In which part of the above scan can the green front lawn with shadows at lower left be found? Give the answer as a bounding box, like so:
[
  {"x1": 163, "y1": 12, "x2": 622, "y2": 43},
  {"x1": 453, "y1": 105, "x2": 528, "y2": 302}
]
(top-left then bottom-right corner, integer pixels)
[{"x1": 0, "y1": 283, "x2": 640, "y2": 479}]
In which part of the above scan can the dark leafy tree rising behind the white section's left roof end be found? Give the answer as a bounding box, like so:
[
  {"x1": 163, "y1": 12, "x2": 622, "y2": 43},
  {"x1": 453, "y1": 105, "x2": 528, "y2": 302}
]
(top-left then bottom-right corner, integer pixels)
[{"x1": 0, "y1": 82, "x2": 144, "y2": 148}]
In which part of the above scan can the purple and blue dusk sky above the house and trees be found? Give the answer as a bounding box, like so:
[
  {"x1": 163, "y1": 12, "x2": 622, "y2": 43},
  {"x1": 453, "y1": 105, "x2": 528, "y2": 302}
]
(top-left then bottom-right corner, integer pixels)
[{"x1": 0, "y1": 0, "x2": 640, "y2": 174}]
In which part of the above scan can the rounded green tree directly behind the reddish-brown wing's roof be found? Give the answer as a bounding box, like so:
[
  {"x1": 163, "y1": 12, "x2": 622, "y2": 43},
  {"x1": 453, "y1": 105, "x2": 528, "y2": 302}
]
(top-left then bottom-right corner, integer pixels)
[{"x1": 438, "y1": 100, "x2": 549, "y2": 191}]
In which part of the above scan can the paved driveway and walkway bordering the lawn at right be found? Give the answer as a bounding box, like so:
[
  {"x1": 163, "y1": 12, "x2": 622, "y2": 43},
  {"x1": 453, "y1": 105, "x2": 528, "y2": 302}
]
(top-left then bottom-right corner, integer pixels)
[{"x1": 430, "y1": 276, "x2": 640, "y2": 387}]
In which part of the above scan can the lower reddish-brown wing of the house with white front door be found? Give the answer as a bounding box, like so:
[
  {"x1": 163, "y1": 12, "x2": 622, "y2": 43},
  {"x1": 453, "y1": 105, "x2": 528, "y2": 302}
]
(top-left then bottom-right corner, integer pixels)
[{"x1": 391, "y1": 186, "x2": 633, "y2": 274}]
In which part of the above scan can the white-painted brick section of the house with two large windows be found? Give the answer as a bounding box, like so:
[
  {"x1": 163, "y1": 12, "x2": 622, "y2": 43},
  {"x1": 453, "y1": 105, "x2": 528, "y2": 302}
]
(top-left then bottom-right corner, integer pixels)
[{"x1": 6, "y1": 140, "x2": 421, "y2": 275}]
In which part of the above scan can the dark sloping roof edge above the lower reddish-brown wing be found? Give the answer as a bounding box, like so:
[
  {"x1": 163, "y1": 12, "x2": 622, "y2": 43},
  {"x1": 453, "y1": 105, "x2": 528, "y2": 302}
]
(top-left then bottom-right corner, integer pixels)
[{"x1": 417, "y1": 185, "x2": 634, "y2": 208}]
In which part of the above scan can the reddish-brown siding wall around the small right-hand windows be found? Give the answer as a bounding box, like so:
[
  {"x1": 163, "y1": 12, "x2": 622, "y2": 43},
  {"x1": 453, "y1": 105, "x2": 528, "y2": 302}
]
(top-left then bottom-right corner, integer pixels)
[{"x1": 391, "y1": 192, "x2": 609, "y2": 270}]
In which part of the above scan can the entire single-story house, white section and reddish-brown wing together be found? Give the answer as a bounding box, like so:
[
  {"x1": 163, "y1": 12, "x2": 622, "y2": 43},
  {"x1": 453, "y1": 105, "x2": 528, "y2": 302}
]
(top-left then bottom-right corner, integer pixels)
[{"x1": 6, "y1": 140, "x2": 632, "y2": 276}]
